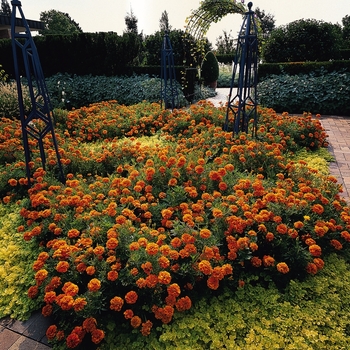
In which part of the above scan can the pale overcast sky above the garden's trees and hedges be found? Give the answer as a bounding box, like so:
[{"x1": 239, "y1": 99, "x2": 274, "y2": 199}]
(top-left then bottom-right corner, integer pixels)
[{"x1": 17, "y1": 0, "x2": 350, "y2": 45}]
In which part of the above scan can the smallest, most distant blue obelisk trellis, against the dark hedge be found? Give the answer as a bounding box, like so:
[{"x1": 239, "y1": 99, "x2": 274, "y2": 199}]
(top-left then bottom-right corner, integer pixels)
[{"x1": 160, "y1": 30, "x2": 179, "y2": 109}]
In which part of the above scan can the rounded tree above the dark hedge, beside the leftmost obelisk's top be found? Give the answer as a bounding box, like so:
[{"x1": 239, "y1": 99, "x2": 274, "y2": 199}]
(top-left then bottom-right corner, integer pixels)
[{"x1": 39, "y1": 10, "x2": 83, "y2": 35}]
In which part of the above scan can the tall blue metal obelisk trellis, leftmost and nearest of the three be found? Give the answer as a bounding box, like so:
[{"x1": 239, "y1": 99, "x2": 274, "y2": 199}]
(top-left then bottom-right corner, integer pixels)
[{"x1": 11, "y1": 0, "x2": 64, "y2": 185}]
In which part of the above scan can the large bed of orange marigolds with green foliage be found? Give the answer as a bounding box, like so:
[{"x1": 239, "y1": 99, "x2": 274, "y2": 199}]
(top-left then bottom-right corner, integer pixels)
[{"x1": 0, "y1": 101, "x2": 350, "y2": 349}]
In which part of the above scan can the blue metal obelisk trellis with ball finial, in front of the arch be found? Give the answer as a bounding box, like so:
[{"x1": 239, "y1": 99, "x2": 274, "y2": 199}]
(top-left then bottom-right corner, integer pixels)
[{"x1": 224, "y1": 2, "x2": 258, "y2": 136}]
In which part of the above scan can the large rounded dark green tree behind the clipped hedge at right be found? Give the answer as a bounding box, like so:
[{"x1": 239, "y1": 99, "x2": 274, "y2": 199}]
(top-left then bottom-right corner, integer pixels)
[{"x1": 263, "y1": 19, "x2": 341, "y2": 62}]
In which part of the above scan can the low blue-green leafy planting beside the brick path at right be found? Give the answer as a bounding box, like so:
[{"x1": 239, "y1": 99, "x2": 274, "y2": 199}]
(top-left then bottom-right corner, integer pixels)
[{"x1": 258, "y1": 72, "x2": 350, "y2": 115}]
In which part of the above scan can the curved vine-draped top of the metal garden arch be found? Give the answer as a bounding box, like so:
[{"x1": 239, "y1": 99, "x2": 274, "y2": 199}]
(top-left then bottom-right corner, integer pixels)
[{"x1": 185, "y1": 0, "x2": 246, "y2": 40}]
